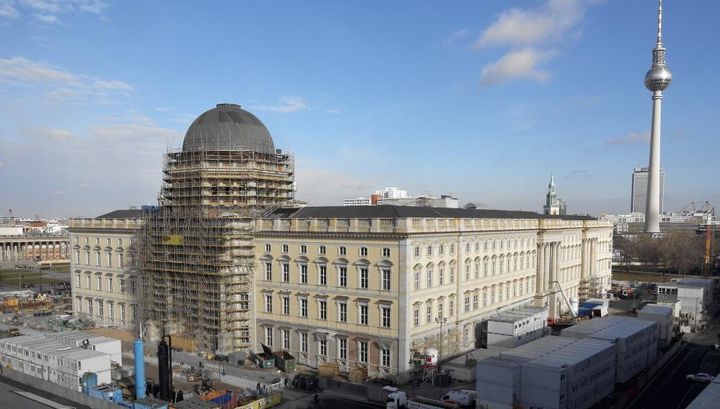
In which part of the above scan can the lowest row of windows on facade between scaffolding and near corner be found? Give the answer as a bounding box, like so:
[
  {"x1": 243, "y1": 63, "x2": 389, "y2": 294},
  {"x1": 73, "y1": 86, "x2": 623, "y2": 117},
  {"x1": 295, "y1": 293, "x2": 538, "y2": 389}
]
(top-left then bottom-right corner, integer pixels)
[{"x1": 265, "y1": 327, "x2": 391, "y2": 368}]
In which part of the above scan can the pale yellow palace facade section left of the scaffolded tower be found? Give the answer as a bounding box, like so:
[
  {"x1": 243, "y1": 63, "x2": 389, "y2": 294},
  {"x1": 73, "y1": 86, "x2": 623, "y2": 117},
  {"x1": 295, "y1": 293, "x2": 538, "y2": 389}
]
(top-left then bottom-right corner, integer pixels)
[{"x1": 69, "y1": 218, "x2": 141, "y2": 330}]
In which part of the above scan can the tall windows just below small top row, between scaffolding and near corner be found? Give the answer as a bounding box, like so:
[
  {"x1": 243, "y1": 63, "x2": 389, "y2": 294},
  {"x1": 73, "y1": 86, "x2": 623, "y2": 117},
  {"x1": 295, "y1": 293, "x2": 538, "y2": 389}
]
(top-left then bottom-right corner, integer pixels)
[{"x1": 264, "y1": 261, "x2": 392, "y2": 291}]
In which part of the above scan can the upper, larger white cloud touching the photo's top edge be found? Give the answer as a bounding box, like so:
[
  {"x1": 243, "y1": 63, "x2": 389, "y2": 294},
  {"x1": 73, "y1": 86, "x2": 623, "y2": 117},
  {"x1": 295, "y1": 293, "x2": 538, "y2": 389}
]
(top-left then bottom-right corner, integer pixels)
[{"x1": 474, "y1": 0, "x2": 588, "y2": 48}]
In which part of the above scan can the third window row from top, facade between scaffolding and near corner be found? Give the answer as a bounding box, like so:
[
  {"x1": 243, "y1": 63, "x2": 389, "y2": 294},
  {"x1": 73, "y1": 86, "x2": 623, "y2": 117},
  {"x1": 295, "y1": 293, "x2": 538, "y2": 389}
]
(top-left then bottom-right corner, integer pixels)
[{"x1": 263, "y1": 294, "x2": 392, "y2": 328}]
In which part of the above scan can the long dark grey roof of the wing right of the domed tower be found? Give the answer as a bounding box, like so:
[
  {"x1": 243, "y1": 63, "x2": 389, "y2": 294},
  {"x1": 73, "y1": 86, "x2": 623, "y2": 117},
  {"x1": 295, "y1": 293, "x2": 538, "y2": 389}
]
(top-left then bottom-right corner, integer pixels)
[{"x1": 269, "y1": 205, "x2": 596, "y2": 220}]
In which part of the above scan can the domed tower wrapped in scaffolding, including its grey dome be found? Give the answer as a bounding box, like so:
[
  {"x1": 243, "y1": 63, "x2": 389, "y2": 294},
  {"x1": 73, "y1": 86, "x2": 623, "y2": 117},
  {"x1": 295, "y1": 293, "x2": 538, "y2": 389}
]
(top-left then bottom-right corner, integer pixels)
[{"x1": 138, "y1": 104, "x2": 294, "y2": 353}]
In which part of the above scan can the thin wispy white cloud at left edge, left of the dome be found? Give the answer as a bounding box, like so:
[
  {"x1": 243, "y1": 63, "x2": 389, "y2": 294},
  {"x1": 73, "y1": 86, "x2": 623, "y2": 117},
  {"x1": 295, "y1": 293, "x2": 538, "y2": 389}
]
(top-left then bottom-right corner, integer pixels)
[{"x1": 0, "y1": 57, "x2": 134, "y2": 104}]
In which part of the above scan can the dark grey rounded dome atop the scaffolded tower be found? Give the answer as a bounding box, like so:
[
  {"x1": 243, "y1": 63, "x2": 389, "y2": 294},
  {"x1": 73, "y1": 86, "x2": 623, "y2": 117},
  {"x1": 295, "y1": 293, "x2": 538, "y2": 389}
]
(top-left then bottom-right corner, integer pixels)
[{"x1": 183, "y1": 104, "x2": 275, "y2": 153}]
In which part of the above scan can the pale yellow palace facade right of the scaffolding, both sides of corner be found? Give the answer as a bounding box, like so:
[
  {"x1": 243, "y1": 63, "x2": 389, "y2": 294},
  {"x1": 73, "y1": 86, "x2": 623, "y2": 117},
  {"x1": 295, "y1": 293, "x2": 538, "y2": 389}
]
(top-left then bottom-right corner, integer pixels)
[{"x1": 254, "y1": 212, "x2": 612, "y2": 375}]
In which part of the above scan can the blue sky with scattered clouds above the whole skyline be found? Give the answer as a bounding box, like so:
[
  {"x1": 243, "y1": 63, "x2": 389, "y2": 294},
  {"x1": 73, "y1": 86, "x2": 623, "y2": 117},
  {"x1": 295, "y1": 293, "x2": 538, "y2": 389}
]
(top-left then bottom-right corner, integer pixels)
[{"x1": 0, "y1": 0, "x2": 720, "y2": 217}]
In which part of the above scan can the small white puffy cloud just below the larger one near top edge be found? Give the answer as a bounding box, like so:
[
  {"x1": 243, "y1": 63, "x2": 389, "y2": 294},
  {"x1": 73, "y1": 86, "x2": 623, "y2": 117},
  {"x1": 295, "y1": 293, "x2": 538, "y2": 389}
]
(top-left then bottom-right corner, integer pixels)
[{"x1": 480, "y1": 48, "x2": 553, "y2": 86}]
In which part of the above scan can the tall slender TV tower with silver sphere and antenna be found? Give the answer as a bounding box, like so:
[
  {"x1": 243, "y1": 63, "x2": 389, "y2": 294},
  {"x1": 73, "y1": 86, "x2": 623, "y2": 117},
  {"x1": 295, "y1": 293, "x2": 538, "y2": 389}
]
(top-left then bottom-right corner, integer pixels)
[{"x1": 645, "y1": 0, "x2": 672, "y2": 233}]
